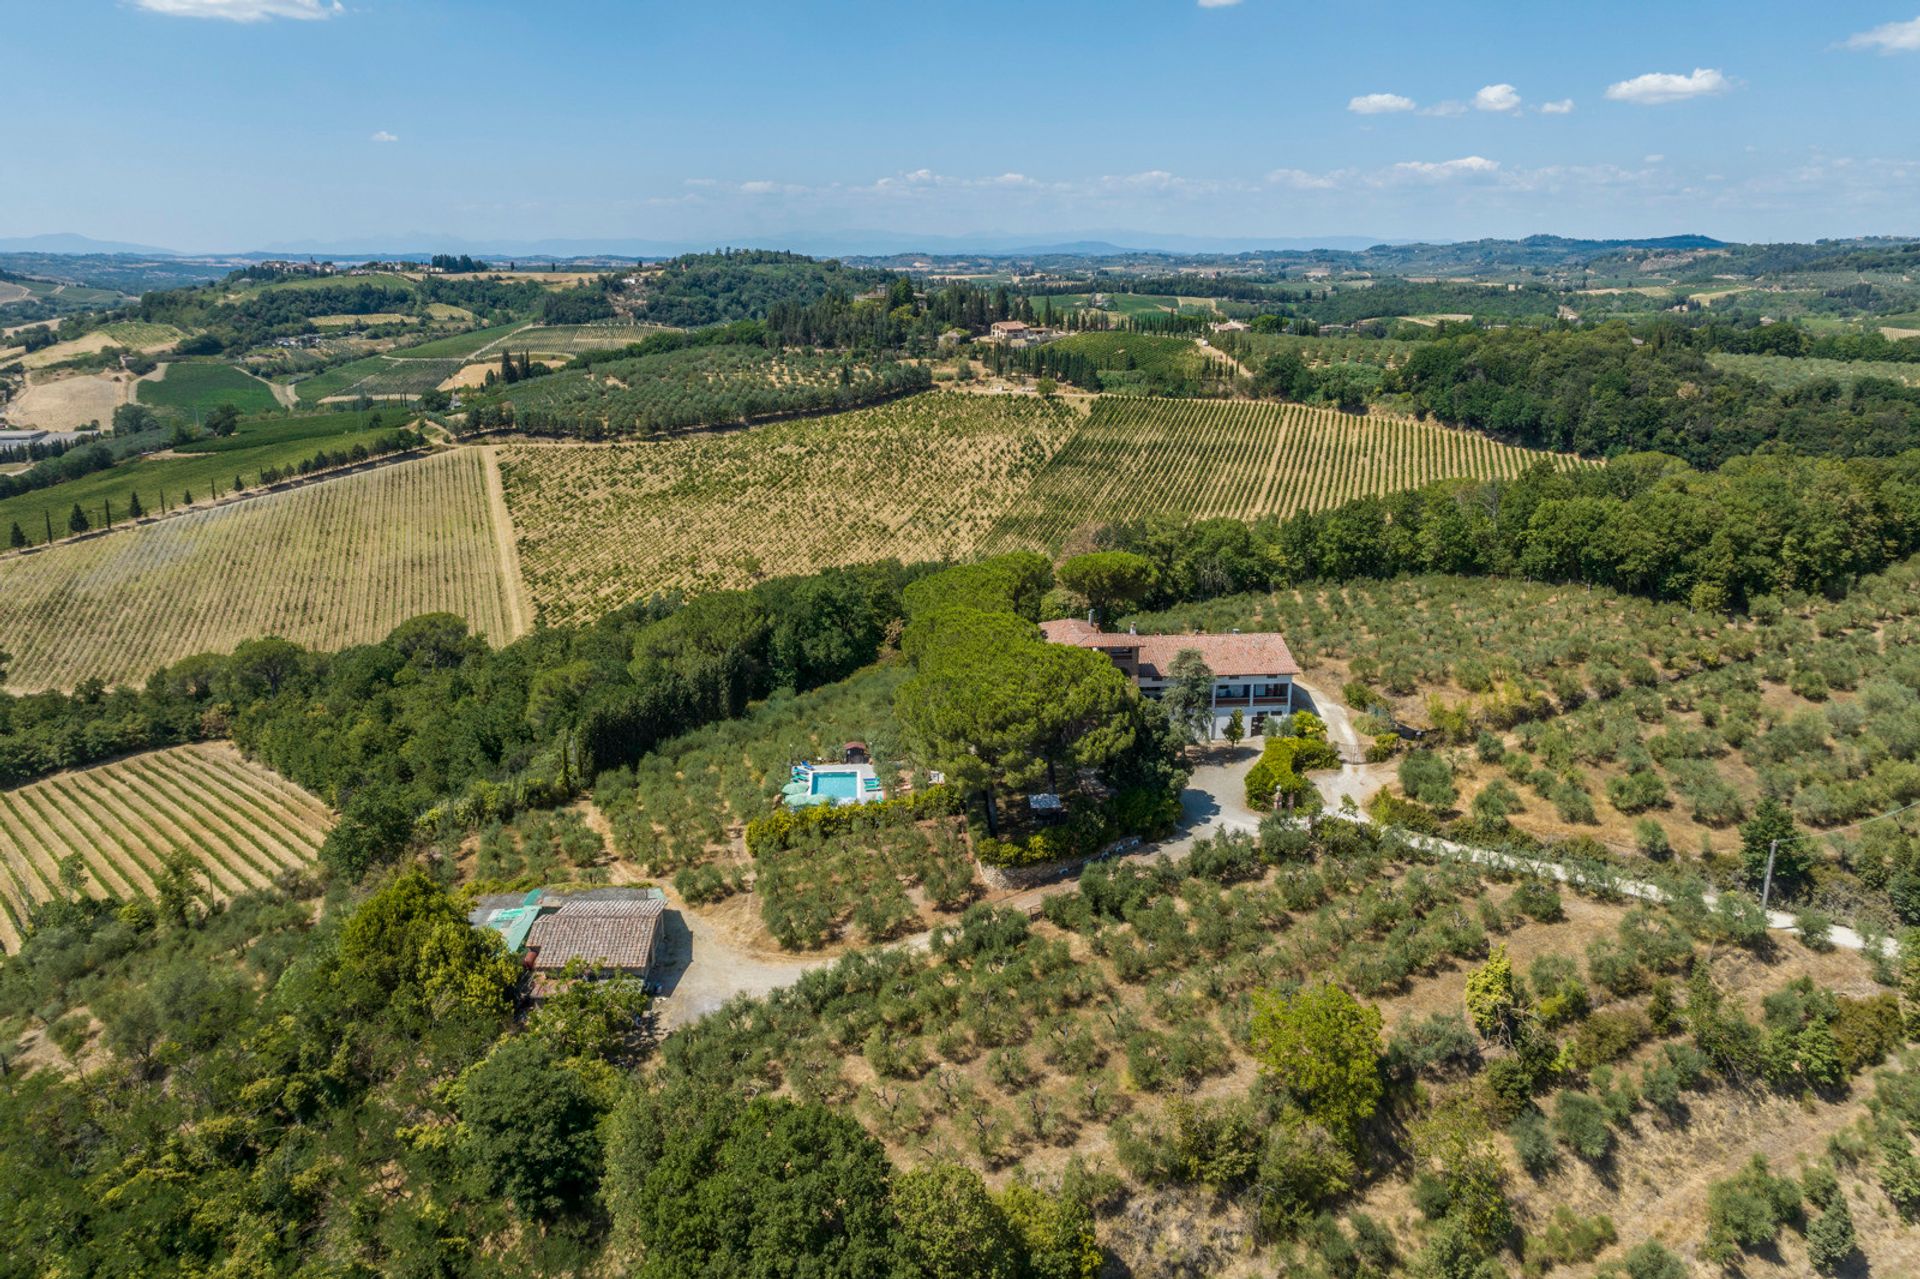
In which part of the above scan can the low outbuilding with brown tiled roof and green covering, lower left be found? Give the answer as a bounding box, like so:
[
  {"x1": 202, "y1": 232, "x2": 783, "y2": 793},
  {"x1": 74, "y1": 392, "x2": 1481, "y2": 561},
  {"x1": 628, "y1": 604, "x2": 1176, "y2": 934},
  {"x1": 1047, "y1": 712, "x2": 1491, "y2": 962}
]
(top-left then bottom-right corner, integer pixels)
[{"x1": 467, "y1": 887, "x2": 666, "y2": 989}]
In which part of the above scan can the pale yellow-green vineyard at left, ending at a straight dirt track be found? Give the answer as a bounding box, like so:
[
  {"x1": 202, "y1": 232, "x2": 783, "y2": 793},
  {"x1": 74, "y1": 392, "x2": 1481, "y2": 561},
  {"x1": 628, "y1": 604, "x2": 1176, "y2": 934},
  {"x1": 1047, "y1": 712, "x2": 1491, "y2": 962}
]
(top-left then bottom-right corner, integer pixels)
[{"x1": 0, "y1": 449, "x2": 513, "y2": 689}]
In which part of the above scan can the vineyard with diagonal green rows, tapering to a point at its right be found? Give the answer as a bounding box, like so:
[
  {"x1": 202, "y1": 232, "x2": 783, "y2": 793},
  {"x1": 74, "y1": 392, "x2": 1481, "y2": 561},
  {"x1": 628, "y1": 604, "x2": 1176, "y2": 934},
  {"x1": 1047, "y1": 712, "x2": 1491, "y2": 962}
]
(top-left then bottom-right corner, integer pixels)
[{"x1": 981, "y1": 398, "x2": 1578, "y2": 553}]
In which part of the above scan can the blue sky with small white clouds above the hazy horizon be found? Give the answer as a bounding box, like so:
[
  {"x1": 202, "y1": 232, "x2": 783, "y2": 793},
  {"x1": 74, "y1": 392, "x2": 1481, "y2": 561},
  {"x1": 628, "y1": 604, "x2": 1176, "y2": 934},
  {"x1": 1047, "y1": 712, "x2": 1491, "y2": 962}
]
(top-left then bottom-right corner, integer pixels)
[{"x1": 0, "y1": 0, "x2": 1920, "y2": 250}]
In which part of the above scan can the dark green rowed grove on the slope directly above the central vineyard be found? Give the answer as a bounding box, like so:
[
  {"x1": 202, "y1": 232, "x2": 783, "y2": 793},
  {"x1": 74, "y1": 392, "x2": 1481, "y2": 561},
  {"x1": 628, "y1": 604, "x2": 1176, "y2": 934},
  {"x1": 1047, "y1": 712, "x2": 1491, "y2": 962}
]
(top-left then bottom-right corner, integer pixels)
[{"x1": 503, "y1": 346, "x2": 931, "y2": 440}]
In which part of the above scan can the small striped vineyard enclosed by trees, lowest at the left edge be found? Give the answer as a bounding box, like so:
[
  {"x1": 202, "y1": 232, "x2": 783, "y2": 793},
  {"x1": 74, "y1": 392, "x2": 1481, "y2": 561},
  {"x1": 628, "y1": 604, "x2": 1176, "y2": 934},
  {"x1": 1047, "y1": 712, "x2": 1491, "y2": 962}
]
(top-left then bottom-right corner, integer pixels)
[{"x1": 0, "y1": 745, "x2": 332, "y2": 953}]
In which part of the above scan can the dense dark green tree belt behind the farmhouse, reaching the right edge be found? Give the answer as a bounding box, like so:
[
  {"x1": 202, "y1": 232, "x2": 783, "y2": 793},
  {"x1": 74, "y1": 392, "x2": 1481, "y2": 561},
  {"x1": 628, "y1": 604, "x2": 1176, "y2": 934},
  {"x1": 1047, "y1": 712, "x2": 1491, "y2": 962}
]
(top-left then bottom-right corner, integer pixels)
[{"x1": 1094, "y1": 449, "x2": 1920, "y2": 611}]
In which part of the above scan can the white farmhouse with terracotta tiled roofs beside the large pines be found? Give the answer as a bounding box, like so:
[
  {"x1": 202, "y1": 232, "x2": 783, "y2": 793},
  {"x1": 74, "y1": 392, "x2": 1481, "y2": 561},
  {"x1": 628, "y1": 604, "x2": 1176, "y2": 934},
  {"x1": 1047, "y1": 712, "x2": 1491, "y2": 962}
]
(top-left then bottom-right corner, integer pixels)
[{"x1": 1041, "y1": 618, "x2": 1300, "y2": 736}]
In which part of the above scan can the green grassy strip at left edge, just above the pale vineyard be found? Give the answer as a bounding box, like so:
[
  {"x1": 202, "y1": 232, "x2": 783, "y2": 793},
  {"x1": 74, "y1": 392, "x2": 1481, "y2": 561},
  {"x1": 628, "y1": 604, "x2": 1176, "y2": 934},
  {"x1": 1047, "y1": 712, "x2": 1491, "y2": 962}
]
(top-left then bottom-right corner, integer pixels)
[{"x1": 0, "y1": 409, "x2": 405, "y2": 545}]
